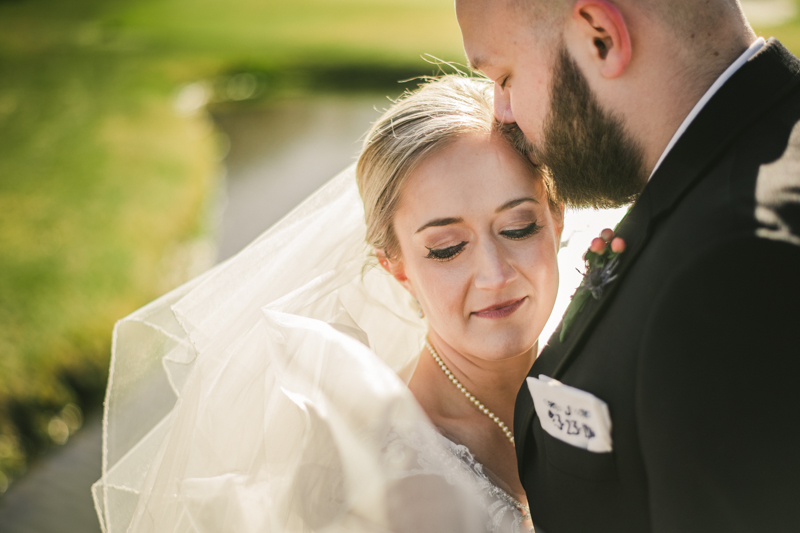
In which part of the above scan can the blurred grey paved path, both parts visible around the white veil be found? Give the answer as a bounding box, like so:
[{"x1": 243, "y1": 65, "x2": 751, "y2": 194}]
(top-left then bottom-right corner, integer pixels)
[{"x1": 0, "y1": 97, "x2": 388, "y2": 533}]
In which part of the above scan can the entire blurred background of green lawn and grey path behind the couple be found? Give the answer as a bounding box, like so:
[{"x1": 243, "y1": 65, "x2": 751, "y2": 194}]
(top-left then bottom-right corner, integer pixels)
[{"x1": 0, "y1": 0, "x2": 800, "y2": 533}]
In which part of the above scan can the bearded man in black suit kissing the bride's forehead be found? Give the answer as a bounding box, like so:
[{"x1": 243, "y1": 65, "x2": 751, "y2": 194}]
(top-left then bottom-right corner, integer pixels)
[{"x1": 456, "y1": 0, "x2": 800, "y2": 533}]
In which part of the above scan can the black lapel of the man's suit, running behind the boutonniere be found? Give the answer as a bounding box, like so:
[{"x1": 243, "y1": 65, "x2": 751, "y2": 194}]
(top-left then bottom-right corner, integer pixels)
[{"x1": 514, "y1": 39, "x2": 800, "y2": 466}]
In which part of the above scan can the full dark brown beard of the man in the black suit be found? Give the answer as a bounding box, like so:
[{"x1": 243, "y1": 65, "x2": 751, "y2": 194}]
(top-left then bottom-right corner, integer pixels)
[{"x1": 517, "y1": 46, "x2": 647, "y2": 208}]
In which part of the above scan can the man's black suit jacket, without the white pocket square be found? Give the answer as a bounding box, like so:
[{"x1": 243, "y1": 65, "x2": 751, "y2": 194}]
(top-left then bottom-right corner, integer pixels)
[{"x1": 514, "y1": 40, "x2": 800, "y2": 533}]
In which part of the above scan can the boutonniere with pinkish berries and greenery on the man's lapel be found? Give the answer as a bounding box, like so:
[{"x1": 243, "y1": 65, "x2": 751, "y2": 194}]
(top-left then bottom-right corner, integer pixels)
[{"x1": 559, "y1": 228, "x2": 625, "y2": 342}]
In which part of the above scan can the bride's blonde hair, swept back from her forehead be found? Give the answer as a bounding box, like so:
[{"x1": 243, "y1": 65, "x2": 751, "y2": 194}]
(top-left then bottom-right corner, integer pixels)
[{"x1": 356, "y1": 75, "x2": 549, "y2": 257}]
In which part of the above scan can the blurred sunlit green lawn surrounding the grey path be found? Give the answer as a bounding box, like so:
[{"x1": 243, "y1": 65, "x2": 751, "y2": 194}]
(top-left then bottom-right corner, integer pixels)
[{"x1": 0, "y1": 0, "x2": 800, "y2": 494}]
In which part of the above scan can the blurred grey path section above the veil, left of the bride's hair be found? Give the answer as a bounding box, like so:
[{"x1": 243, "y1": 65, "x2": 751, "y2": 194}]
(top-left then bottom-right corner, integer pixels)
[{"x1": 215, "y1": 96, "x2": 390, "y2": 260}]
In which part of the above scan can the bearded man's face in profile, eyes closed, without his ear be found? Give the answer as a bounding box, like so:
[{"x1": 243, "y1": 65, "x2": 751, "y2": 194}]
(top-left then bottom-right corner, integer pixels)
[{"x1": 456, "y1": 0, "x2": 647, "y2": 207}]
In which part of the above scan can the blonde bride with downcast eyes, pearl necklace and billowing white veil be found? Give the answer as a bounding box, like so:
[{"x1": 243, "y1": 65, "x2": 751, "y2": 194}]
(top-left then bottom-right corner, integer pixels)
[{"x1": 93, "y1": 76, "x2": 608, "y2": 533}]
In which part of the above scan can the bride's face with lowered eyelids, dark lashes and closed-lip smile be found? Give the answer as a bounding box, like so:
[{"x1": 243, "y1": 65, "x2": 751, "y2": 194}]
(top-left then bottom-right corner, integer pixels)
[{"x1": 389, "y1": 134, "x2": 562, "y2": 360}]
